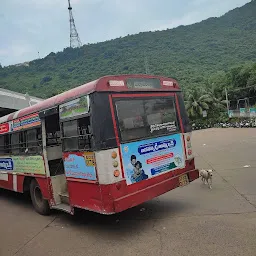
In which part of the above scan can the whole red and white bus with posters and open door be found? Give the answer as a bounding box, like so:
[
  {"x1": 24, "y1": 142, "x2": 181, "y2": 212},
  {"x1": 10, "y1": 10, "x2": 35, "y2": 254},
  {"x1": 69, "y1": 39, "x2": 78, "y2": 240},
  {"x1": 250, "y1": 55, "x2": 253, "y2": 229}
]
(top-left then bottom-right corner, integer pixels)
[{"x1": 0, "y1": 75, "x2": 198, "y2": 215}]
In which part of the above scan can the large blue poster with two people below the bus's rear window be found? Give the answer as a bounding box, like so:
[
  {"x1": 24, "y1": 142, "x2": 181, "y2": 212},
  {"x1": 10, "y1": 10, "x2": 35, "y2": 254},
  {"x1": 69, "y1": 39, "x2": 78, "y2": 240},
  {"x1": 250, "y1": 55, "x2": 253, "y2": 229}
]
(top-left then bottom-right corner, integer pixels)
[{"x1": 121, "y1": 134, "x2": 185, "y2": 185}]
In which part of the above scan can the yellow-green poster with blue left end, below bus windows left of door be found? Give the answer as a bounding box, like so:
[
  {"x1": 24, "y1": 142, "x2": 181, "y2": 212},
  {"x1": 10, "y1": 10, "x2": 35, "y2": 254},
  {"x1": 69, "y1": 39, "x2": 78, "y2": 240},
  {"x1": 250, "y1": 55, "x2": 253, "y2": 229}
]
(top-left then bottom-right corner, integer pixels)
[{"x1": 0, "y1": 156, "x2": 45, "y2": 174}]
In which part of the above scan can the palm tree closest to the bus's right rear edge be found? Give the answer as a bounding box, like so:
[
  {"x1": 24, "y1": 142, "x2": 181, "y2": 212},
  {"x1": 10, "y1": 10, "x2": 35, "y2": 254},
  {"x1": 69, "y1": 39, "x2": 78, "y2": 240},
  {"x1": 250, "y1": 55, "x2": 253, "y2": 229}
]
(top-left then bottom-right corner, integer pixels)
[{"x1": 185, "y1": 89, "x2": 213, "y2": 118}]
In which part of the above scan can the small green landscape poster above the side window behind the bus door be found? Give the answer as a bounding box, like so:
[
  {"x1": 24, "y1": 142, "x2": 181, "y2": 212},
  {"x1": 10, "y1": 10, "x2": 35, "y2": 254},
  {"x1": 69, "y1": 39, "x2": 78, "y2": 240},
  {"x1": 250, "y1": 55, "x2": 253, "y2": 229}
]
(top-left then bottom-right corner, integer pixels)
[{"x1": 59, "y1": 95, "x2": 89, "y2": 120}]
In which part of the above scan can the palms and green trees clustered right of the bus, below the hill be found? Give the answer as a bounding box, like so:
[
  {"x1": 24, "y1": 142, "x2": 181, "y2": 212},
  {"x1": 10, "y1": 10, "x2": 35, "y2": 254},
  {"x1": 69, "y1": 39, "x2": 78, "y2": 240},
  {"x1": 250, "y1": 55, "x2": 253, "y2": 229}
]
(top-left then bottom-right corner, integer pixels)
[{"x1": 185, "y1": 63, "x2": 256, "y2": 121}]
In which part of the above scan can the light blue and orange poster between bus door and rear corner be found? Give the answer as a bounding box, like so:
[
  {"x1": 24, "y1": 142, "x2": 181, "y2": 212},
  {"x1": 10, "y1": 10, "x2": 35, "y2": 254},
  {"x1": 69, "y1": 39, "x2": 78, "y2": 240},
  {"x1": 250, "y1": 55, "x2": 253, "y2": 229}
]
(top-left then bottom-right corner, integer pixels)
[{"x1": 64, "y1": 152, "x2": 96, "y2": 180}]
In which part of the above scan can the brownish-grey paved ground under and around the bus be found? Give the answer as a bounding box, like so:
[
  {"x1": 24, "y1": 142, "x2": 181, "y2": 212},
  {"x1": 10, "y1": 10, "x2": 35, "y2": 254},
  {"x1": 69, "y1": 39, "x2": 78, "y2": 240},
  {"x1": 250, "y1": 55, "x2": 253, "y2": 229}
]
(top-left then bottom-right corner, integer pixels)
[{"x1": 0, "y1": 129, "x2": 256, "y2": 256}]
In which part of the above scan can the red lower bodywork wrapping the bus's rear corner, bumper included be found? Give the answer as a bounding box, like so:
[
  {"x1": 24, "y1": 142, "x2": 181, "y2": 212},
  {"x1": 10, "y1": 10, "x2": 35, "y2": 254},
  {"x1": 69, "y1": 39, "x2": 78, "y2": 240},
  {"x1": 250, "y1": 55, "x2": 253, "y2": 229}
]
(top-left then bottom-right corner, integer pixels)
[{"x1": 68, "y1": 156, "x2": 199, "y2": 214}]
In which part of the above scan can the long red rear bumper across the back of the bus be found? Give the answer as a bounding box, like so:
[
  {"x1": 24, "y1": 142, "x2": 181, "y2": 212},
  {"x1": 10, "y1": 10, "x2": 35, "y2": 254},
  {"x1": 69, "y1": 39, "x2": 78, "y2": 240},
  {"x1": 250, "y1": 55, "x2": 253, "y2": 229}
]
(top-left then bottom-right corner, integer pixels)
[{"x1": 114, "y1": 169, "x2": 199, "y2": 213}]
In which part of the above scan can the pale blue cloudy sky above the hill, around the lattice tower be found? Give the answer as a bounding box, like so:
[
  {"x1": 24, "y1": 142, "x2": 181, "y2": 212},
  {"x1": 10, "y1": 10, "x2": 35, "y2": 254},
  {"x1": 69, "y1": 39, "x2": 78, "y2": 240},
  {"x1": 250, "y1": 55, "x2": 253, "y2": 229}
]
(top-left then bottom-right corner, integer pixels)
[{"x1": 0, "y1": 0, "x2": 250, "y2": 66}]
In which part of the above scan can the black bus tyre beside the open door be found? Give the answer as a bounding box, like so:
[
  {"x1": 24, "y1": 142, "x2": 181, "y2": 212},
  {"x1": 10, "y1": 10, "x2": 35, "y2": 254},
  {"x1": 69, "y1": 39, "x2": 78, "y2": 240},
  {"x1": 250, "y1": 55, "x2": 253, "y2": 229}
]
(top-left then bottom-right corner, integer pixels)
[{"x1": 30, "y1": 180, "x2": 50, "y2": 215}]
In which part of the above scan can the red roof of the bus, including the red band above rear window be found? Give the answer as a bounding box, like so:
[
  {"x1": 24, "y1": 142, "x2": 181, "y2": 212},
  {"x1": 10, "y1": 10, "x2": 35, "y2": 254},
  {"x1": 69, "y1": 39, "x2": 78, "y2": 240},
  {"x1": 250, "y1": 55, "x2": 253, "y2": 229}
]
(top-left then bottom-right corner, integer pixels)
[{"x1": 0, "y1": 75, "x2": 180, "y2": 124}]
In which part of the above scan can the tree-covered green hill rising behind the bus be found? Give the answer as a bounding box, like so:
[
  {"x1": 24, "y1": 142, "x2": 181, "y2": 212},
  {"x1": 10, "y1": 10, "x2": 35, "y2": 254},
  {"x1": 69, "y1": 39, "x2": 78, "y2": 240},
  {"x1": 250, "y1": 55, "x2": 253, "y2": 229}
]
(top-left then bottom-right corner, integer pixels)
[{"x1": 0, "y1": 0, "x2": 256, "y2": 97}]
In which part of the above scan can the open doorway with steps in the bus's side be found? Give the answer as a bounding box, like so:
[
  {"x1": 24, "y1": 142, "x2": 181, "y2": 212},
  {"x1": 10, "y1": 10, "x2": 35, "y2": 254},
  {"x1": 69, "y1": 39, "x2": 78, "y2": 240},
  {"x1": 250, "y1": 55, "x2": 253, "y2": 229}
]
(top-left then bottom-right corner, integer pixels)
[{"x1": 40, "y1": 107, "x2": 69, "y2": 211}]
